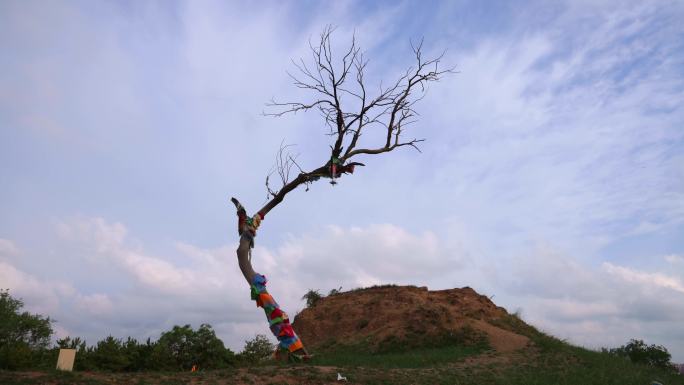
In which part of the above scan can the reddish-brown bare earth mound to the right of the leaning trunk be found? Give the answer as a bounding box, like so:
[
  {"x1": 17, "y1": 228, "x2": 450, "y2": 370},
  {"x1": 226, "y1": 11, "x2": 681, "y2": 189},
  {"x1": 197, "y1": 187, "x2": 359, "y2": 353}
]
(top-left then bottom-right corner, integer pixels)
[{"x1": 293, "y1": 286, "x2": 533, "y2": 352}]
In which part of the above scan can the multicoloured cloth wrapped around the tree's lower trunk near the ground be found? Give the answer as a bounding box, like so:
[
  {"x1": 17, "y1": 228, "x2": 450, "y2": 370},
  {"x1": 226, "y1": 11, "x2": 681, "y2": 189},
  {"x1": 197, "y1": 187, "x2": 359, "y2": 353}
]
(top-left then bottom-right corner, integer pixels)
[{"x1": 250, "y1": 274, "x2": 304, "y2": 352}]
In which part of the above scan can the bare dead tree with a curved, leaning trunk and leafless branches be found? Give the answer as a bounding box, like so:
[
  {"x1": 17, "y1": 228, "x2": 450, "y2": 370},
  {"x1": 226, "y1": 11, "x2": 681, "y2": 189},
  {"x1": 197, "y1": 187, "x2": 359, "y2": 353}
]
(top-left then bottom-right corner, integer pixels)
[{"x1": 232, "y1": 27, "x2": 453, "y2": 360}]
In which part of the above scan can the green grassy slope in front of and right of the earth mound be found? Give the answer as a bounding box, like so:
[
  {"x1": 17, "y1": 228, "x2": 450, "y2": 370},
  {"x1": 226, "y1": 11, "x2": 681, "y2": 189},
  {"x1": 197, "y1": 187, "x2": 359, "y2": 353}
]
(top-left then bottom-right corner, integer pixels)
[{"x1": 300, "y1": 331, "x2": 684, "y2": 385}]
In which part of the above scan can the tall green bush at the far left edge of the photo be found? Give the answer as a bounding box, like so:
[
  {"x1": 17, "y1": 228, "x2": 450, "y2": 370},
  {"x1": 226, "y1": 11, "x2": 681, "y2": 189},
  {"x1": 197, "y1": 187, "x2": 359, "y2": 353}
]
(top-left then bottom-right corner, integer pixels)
[{"x1": 0, "y1": 290, "x2": 52, "y2": 370}]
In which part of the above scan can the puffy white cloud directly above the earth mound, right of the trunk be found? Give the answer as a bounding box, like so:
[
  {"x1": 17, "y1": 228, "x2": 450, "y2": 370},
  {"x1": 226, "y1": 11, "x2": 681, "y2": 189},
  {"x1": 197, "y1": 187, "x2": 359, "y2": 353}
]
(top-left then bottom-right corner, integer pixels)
[{"x1": 275, "y1": 224, "x2": 454, "y2": 288}]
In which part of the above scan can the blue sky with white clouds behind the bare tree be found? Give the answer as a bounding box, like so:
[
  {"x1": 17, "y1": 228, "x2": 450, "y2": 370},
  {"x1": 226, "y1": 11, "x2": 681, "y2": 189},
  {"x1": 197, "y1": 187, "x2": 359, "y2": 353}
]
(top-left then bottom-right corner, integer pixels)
[{"x1": 0, "y1": 1, "x2": 684, "y2": 361}]
